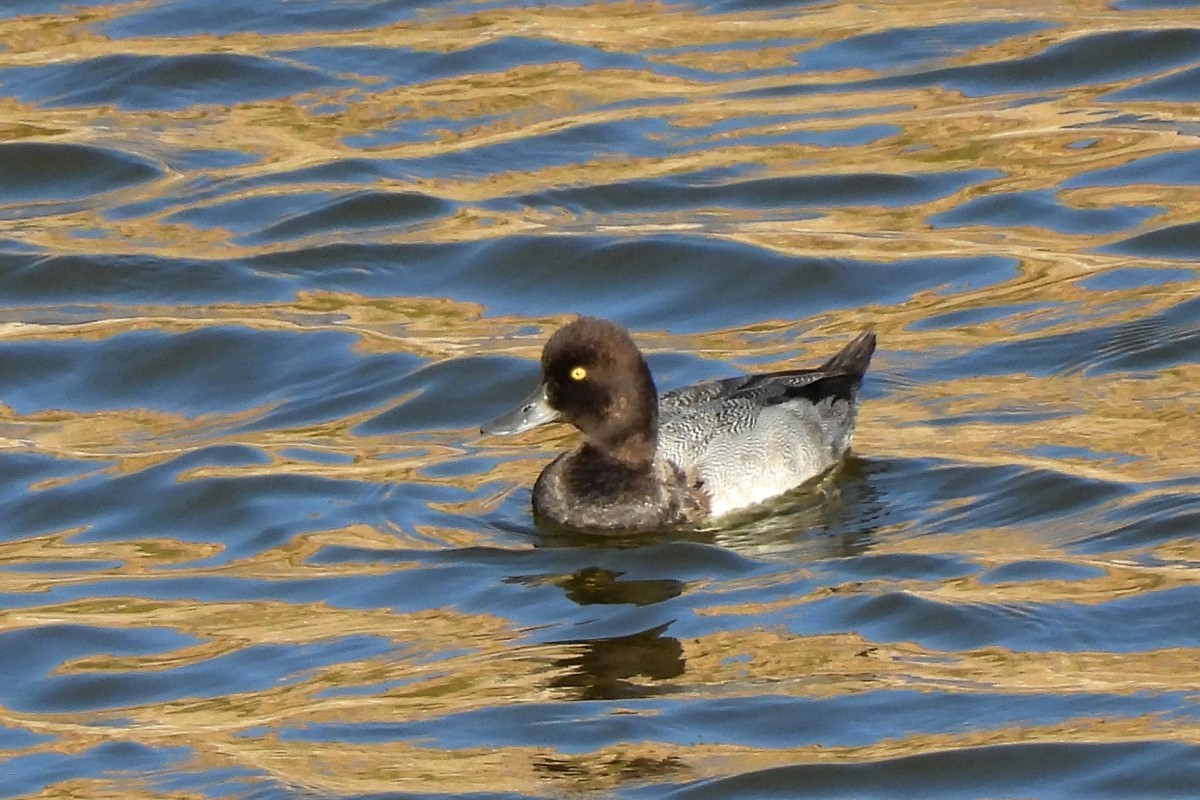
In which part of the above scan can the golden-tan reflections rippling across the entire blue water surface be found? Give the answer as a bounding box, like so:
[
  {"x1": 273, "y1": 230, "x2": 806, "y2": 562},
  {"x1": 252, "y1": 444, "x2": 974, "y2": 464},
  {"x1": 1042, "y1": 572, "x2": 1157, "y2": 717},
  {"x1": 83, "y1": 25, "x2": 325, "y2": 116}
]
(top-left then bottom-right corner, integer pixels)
[{"x1": 0, "y1": 0, "x2": 1200, "y2": 798}]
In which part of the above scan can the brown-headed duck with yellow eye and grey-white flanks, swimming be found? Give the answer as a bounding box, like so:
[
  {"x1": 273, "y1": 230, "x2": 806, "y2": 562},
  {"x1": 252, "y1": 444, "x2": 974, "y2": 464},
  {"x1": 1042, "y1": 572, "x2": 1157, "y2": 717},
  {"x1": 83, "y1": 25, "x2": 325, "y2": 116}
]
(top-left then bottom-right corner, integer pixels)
[{"x1": 480, "y1": 317, "x2": 876, "y2": 533}]
